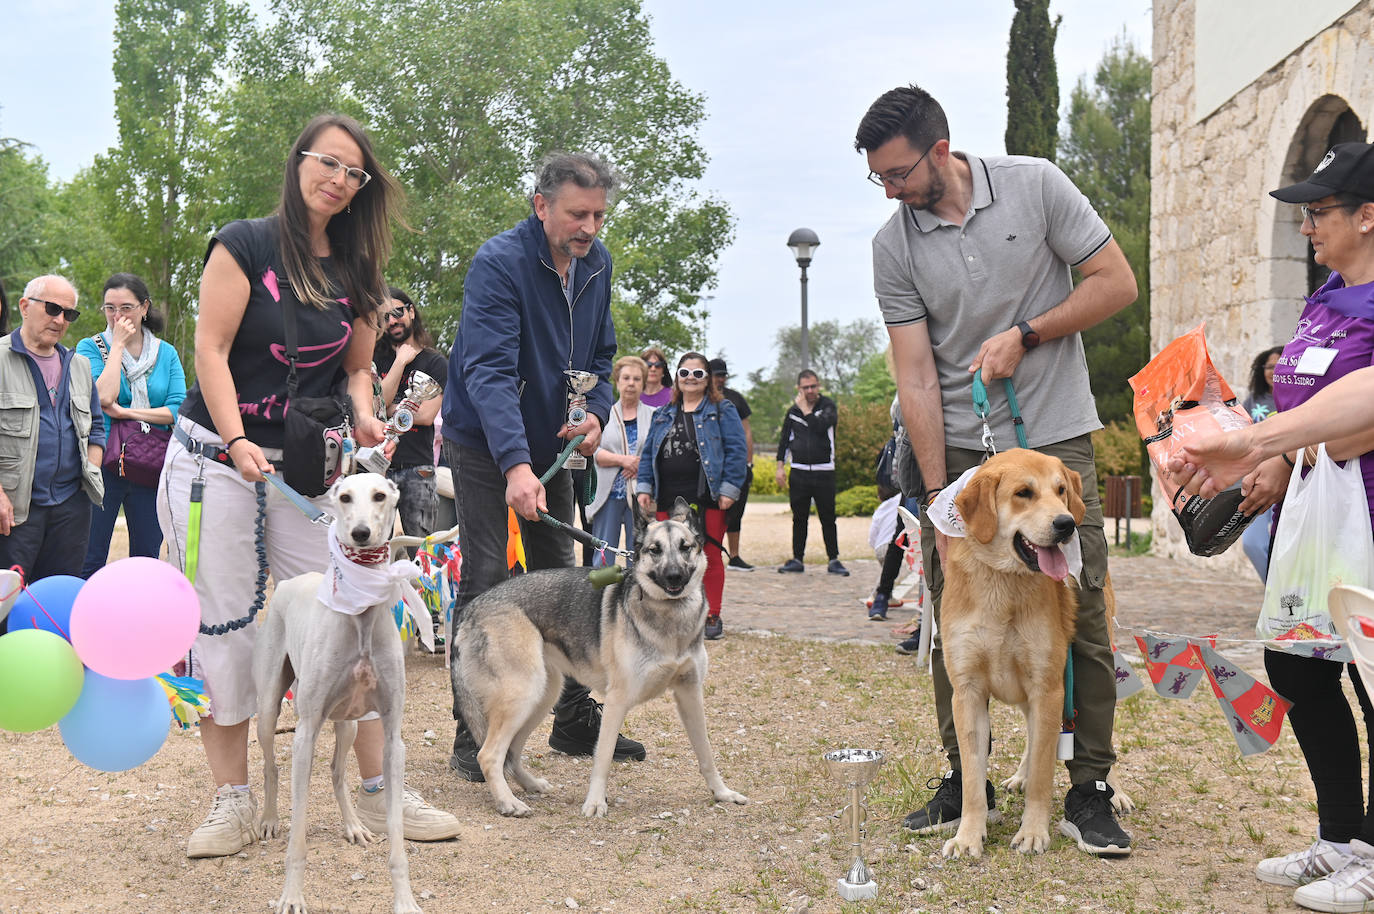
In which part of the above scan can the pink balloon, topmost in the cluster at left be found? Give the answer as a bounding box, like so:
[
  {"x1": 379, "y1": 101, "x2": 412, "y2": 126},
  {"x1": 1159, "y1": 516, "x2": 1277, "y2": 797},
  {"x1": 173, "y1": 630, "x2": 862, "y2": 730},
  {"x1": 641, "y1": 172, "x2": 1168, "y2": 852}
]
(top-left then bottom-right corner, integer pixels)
[{"x1": 71, "y1": 555, "x2": 201, "y2": 679}]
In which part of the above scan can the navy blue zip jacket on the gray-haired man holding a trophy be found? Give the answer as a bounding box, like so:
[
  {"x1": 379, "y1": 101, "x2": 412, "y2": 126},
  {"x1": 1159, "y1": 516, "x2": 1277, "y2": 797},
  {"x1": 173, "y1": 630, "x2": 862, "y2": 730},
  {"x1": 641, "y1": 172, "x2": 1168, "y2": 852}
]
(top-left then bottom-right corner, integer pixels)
[{"x1": 442, "y1": 214, "x2": 616, "y2": 473}]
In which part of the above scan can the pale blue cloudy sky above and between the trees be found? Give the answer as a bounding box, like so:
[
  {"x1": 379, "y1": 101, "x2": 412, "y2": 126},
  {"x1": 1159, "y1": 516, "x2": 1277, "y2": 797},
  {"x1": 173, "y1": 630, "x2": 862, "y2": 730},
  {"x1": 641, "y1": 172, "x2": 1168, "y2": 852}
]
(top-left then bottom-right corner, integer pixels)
[{"x1": 0, "y1": 0, "x2": 1150, "y2": 375}]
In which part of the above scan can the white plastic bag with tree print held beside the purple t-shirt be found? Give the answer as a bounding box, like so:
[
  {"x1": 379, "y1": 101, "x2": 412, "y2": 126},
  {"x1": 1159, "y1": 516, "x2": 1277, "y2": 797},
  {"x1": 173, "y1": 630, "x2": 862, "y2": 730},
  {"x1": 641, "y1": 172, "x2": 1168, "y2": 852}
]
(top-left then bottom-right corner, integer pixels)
[{"x1": 1254, "y1": 444, "x2": 1374, "y2": 638}]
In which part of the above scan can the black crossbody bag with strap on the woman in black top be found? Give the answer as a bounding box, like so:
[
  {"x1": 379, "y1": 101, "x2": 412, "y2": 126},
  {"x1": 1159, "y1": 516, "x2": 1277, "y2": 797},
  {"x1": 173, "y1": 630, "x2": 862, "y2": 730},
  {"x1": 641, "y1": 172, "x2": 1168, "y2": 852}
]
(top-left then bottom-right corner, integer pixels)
[{"x1": 282, "y1": 296, "x2": 353, "y2": 498}]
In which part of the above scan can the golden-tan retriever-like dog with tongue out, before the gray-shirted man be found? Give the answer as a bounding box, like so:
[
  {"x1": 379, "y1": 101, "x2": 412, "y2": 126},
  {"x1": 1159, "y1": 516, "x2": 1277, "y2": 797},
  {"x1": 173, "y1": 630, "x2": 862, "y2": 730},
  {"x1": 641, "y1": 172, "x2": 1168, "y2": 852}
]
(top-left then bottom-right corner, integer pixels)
[{"x1": 940, "y1": 448, "x2": 1088, "y2": 858}]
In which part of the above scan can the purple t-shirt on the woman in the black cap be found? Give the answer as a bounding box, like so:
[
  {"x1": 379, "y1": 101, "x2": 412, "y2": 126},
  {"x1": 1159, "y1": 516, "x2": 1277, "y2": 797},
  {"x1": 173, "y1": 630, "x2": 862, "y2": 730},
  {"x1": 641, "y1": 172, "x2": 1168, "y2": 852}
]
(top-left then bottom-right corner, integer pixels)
[{"x1": 1274, "y1": 272, "x2": 1374, "y2": 524}]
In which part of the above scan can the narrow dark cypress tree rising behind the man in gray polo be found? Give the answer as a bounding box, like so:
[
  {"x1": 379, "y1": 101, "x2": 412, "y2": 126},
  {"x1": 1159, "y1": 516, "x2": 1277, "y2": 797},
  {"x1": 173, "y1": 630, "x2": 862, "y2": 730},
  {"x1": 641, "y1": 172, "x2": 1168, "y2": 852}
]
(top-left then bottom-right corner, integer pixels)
[{"x1": 1006, "y1": 0, "x2": 1063, "y2": 161}]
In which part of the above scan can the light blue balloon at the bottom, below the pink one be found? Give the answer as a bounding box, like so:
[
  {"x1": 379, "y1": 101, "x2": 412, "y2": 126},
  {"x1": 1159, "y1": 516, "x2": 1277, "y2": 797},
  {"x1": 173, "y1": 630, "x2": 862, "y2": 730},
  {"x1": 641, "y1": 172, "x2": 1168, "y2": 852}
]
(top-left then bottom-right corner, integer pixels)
[{"x1": 58, "y1": 672, "x2": 172, "y2": 771}]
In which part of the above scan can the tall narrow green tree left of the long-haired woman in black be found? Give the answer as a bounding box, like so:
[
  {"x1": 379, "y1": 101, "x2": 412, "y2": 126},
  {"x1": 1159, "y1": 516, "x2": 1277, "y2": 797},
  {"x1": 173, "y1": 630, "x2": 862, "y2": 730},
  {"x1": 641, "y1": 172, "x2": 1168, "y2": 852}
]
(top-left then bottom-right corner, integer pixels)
[{"x1": 103, "y1": 0, "x2": 247, "y2": 363}]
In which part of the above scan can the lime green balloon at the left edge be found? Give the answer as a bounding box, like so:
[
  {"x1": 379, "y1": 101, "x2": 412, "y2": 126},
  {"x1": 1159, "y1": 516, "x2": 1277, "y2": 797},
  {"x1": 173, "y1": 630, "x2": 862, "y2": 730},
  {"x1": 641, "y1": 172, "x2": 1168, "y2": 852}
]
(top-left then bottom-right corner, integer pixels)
[{"x1": 0, "y1": 628, "x2": 85, "y2": 733}]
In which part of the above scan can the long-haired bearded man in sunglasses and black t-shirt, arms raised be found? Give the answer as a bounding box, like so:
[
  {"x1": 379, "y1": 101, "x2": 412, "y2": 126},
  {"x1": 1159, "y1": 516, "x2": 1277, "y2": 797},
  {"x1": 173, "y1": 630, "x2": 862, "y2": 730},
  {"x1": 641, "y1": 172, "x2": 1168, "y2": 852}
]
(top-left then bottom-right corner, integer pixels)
[{"x1": 372, "y1": 286, "x2": 448, "y2": 549}]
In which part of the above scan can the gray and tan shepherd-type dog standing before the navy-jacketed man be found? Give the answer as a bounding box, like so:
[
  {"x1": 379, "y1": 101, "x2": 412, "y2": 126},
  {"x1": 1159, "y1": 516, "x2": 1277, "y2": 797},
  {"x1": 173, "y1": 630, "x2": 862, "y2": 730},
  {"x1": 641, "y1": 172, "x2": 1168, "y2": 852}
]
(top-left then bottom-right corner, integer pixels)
[{"x1": 453, "y1": 499, "x2": 749, "y2": 816}]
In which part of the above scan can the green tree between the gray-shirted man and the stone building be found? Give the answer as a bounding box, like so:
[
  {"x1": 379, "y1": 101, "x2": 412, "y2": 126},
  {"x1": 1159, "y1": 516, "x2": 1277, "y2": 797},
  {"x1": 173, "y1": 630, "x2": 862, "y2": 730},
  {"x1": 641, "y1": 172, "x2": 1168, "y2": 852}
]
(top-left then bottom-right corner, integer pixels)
[{"x1": 1059, "y1": 32, "x2": 1150, "y2": 422}]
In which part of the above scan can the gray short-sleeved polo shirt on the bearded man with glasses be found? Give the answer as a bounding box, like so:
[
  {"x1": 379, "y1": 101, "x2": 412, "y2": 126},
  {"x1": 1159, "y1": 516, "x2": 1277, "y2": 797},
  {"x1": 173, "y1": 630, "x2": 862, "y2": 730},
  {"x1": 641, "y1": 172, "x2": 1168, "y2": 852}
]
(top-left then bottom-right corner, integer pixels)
[{"x1": 872, "y1": 153, "x2": 1112, "y2": 449}]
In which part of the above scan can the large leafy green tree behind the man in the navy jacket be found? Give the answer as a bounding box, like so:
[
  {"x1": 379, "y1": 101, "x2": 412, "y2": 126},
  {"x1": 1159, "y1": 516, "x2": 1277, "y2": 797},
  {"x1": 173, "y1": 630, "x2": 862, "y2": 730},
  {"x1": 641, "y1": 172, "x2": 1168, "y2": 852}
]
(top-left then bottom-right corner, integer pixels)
[{"x1": 224, "y1": 0, "x2": 732, "y2": 350}]
